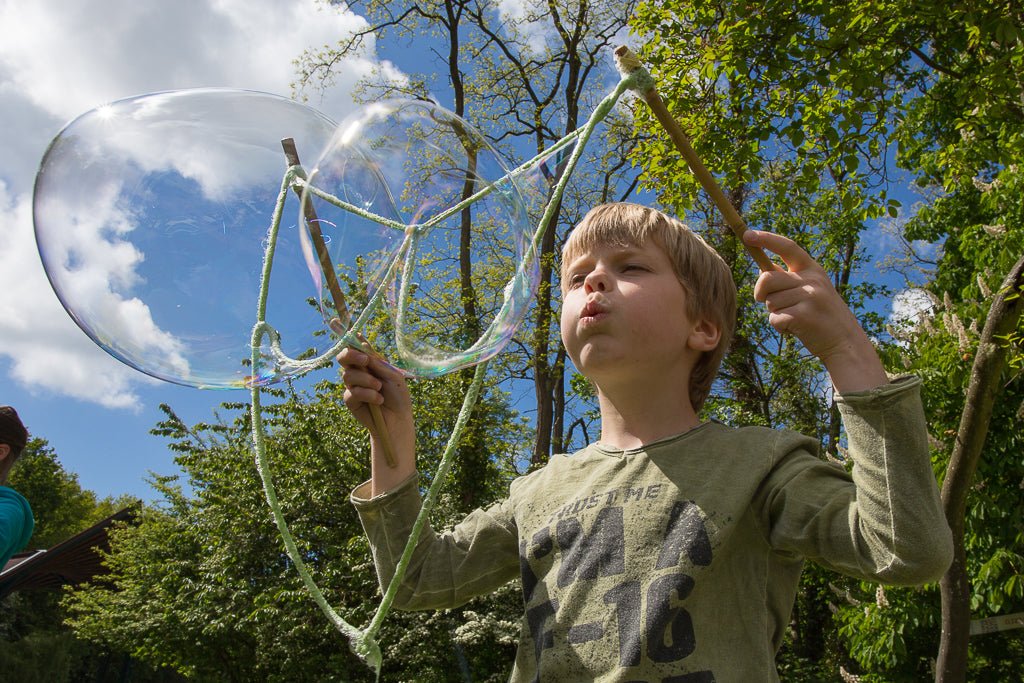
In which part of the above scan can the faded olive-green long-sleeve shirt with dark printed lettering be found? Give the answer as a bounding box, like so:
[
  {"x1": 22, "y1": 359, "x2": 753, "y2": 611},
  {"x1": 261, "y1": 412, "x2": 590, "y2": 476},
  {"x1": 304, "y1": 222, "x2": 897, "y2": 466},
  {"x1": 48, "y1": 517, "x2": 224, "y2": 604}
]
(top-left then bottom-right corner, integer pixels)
[{"x1": 352, "y1": 378, "x2": 952, "y2": 683}]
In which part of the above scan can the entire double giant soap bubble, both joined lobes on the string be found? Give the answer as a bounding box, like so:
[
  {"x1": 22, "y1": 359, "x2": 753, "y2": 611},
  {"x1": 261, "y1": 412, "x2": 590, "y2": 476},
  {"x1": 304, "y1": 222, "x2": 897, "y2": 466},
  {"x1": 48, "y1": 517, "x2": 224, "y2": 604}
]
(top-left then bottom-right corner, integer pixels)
[{"x1": 34, "y1": 89, "x2": 537, "y2": 388}]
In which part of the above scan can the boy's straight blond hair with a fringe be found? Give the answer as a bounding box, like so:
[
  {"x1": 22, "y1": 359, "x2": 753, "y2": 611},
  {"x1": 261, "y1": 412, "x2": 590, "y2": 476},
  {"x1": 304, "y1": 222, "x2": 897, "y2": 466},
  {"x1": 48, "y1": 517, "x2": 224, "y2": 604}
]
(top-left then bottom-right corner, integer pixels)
[{"x1": 561, "y1": 203, "x2": 736, "y2": 411}]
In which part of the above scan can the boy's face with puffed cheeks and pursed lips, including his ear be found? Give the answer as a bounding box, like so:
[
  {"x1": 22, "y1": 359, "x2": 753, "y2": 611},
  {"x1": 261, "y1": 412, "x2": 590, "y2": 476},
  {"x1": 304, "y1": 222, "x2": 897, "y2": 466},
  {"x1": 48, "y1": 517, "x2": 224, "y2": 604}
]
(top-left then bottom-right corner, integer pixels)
[{"x1": 561, "y1": 241, "x2": 718, "y2": 386}]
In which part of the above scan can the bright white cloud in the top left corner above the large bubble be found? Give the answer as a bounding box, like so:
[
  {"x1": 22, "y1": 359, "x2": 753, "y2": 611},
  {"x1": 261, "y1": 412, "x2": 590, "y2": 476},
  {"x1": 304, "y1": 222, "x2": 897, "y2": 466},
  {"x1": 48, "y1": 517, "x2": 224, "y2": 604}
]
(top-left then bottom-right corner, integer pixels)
[{"x1": 0, "y1": 0, "x2": 369, "y2": 120}]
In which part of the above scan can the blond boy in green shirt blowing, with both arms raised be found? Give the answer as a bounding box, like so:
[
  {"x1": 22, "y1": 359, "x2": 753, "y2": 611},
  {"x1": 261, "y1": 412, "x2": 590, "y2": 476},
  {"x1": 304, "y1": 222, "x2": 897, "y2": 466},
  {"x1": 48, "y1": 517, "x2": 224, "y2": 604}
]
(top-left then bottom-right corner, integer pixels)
[{"x1": 338, "y1": 204, "x2": 952, "y2": 683}]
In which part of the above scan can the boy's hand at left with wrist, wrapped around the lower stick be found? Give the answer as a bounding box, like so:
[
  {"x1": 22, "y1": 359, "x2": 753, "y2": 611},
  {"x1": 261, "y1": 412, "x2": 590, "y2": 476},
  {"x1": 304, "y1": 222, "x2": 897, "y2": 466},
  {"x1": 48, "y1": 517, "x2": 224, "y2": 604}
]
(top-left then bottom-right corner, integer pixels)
[{"x1": 337, "y1": 348, "x2": 416, "y2": 496}]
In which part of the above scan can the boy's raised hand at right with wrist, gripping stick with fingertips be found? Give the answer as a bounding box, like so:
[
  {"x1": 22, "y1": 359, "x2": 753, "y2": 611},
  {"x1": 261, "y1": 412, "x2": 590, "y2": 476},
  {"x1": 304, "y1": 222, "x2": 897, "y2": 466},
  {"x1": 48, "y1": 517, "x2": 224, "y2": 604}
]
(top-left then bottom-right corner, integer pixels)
[{"x1": 743, "y1": 230, "x2": 889, "y2": 392}]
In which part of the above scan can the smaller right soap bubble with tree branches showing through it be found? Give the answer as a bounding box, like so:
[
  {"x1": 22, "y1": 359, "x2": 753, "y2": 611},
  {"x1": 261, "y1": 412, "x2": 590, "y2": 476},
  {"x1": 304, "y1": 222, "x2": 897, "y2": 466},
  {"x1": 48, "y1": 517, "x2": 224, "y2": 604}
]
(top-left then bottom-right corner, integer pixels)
[{"x1": 302, "y1": 100, "x2": 539, "y2": 377}]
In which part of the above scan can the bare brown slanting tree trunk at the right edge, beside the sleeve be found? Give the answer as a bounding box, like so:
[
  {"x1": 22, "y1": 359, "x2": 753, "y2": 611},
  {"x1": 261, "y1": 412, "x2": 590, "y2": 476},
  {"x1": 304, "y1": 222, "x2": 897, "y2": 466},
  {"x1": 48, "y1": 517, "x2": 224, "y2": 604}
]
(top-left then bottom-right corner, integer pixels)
[{"x1": 935, "y1": 256, "x2": 1024, "y2": 683}]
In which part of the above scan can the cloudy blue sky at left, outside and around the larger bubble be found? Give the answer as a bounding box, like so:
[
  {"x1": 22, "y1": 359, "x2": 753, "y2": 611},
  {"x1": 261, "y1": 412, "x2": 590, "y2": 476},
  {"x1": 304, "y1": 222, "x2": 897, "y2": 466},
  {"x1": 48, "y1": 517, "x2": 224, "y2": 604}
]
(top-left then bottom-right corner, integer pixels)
[{"x1": 0, "y1": 0, "x2": 389, "y2": 500}]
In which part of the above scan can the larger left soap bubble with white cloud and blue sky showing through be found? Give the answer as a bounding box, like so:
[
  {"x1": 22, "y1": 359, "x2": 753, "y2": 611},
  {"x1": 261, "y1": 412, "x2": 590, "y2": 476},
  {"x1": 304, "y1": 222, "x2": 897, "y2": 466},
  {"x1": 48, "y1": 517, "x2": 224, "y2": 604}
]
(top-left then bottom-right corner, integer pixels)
[{"x1": 34, "y1": 89, "x2": 350, "y2": 387}]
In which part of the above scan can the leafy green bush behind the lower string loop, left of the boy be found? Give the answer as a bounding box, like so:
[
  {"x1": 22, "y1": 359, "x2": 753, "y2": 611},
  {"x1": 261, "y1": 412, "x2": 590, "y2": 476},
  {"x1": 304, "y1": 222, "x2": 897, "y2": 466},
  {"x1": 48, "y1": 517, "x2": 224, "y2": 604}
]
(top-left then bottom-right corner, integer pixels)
[{"x1": 67, "y1": 375, "x2": 521, "y2": 681}]
